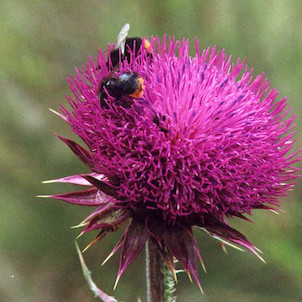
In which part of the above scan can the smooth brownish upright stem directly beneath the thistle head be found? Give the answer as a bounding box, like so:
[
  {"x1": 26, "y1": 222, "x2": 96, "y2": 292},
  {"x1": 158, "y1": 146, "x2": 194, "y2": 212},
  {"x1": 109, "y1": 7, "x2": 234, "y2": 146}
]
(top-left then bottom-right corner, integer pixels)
[{"x1": 146, "y1": 240, "x2": 165, "y2": 302}]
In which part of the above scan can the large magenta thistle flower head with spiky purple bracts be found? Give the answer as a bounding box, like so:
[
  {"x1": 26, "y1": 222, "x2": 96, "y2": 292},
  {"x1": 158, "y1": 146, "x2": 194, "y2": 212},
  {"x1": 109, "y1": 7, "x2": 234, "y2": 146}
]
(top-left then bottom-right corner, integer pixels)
[{"x1": 45, "y1": 37, "x2": 300, "y2": 285}]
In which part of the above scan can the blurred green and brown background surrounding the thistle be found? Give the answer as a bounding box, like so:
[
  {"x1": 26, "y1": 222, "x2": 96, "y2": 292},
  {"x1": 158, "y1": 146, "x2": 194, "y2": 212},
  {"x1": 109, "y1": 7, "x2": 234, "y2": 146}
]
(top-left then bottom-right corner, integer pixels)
[{"x1": 0, "y1": 0, "x2": 302, "y2": 302}]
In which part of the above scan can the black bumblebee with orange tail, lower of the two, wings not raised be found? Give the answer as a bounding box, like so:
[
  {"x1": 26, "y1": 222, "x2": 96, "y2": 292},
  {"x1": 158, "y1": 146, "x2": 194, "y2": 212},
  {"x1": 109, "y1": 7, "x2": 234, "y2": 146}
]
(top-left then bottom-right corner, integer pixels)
[{"x1": 98, "y1": 72, "x2": 145, "y2": 109}]
